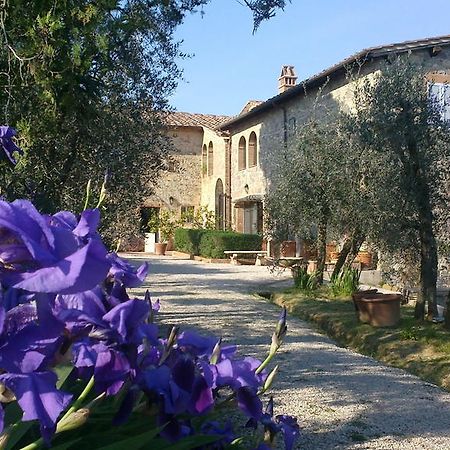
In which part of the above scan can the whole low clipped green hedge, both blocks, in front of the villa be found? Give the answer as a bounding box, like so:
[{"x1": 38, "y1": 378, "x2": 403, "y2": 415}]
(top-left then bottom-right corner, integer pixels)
[{"x1": 175, "y1": 228, "x2": 262, "y2": 258}]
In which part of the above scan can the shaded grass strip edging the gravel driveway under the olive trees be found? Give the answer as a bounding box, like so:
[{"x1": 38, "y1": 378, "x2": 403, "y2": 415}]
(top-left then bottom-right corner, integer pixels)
[{"x1": 271, "y1": 287, "x2": 450, "y2": 391}]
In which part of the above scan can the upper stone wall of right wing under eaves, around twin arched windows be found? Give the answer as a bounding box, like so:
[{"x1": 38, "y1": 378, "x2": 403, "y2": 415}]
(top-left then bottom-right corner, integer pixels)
[{"x1": 225, "y1": 48, "x2": 450, "y2": 229}]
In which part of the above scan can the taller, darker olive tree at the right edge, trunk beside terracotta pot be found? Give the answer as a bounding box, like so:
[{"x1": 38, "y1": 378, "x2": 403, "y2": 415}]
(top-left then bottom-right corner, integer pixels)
[{"x1": 351, "y1": 58, "x2": 450, "y2": 319}]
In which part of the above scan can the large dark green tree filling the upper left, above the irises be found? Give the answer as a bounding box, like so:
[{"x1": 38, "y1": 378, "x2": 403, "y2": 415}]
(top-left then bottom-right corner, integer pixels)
[{"x1": 0, "y1": 0, "x2": 204, "y2": 243}]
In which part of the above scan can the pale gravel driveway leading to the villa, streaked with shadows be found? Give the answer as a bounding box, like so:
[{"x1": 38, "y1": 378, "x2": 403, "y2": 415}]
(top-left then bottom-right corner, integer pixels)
[{"x1": 125, "y1": 255, "x2": 450, "y2": 450}]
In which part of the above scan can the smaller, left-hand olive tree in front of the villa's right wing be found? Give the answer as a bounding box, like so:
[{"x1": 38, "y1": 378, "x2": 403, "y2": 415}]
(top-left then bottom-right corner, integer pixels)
[{"x1": 266, "y1": 107, "x2": 365, "y2": 282}]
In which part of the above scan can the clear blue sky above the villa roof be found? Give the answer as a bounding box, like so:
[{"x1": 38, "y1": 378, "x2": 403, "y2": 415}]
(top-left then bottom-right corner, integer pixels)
[{"x1": 170, "y1": 0, "x2": 450, "y2": 115}]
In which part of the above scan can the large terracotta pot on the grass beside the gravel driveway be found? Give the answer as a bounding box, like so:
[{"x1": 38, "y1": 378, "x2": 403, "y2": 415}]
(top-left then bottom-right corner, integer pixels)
[{"x1": 357, "y1": 293, "x2": 402, "y2": 327}]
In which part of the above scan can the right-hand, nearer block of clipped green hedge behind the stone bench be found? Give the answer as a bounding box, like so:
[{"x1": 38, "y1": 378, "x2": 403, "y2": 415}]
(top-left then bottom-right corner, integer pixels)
[{"x1": 199, "y1": 230, "x2": 262, "y2": 258}]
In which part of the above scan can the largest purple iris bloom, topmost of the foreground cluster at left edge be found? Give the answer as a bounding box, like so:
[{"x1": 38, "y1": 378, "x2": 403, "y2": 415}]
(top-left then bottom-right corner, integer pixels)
[{"x1": 0, "y1": 200, "x2": 110, "y2": 294}]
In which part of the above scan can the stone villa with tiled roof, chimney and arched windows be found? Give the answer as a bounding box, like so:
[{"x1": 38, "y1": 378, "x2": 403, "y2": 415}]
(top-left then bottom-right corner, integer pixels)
[{"x1": 144, "y1": 36, "x2": 450, "y2": 239}]
